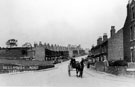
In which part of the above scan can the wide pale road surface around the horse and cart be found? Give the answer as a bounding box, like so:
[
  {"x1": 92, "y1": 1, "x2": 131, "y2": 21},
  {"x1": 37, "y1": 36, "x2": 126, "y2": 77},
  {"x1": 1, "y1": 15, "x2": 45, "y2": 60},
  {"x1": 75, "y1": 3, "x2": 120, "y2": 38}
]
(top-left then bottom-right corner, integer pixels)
[{"x1": 0, "y1": 57, "x2": 135, "y2": 87}]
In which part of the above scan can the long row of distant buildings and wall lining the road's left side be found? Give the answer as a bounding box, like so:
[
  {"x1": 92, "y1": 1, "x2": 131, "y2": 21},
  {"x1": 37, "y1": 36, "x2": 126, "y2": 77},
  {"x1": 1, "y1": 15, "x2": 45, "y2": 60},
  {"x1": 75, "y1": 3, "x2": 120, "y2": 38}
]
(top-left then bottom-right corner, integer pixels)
[{"x1": 0, "y1": 42, "x2": 85, "y2": 61}]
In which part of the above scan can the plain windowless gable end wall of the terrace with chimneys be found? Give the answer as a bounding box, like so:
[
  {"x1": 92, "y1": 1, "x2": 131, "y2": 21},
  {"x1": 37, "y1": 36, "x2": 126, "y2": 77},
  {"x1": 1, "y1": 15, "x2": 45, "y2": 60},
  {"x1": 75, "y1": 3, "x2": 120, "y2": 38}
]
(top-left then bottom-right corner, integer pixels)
[{"x1": 108, "y1": 29, "x2": 124, "y2": 60}]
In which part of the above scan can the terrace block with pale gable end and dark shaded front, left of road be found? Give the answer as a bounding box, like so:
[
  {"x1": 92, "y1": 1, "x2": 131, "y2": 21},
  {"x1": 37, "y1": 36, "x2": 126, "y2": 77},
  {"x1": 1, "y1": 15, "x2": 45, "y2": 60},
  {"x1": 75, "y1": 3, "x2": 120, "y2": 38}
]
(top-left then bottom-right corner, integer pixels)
[{"x1": 33, "y1": 44, "x2": 69, "y2": 61}]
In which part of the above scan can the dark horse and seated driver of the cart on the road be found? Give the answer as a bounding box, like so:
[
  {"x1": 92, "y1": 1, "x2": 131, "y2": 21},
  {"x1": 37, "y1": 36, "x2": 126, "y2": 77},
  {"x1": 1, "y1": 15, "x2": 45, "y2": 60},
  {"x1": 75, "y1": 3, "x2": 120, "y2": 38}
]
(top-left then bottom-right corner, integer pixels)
[{"x1": 70, "y1": 58, "x2": 84, "y2": 77}]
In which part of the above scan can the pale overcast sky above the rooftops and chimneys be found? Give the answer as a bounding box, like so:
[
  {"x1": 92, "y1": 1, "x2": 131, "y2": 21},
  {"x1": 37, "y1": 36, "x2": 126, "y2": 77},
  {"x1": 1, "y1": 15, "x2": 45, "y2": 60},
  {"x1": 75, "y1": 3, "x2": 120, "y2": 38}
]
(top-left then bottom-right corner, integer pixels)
[{"x1": 0, "y1": 0, "x2": 128, "y2": 48}]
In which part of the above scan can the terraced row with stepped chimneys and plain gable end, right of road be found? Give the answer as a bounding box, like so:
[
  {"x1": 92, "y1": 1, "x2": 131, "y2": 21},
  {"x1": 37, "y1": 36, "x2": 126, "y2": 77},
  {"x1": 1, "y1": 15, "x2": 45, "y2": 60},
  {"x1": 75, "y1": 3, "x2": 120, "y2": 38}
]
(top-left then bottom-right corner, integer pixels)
[{"x1": 90, "y1": 26, "x2": 124, "y2": 61}]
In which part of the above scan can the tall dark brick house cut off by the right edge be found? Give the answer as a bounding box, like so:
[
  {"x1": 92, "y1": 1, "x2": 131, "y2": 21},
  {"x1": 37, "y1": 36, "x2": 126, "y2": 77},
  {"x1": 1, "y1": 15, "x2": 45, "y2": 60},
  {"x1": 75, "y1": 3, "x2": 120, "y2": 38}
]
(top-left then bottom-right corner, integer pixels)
[{"x1": 123, "y1": 0, "x2": 135, "y2": 62}]
